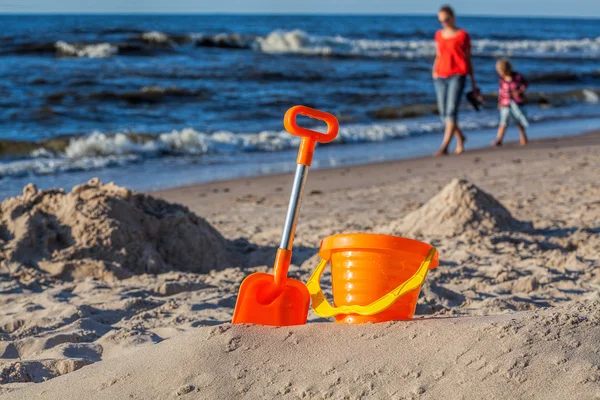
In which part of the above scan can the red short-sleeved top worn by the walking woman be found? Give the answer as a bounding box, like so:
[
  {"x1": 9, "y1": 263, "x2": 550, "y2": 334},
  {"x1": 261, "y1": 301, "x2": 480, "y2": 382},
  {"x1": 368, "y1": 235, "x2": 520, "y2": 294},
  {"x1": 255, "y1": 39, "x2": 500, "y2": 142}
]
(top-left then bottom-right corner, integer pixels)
[{"x1": 435, "y1": 29, "x2": 471, "y2": 78}]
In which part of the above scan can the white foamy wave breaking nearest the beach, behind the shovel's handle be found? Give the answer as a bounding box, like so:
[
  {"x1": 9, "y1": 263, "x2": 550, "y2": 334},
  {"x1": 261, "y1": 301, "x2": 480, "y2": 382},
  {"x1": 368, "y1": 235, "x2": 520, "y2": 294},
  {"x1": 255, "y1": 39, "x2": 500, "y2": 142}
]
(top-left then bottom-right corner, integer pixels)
[{"x1": 0, "y1": 122, "x2": 418, "y2": 178}]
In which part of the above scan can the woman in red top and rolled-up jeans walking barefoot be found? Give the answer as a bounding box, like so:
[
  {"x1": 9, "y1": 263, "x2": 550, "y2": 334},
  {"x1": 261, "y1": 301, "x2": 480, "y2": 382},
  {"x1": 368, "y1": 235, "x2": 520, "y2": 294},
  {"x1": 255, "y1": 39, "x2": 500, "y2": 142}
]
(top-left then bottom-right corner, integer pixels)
[{"x1": 432, "y1": 6, "x2": 478, "y2": 156}]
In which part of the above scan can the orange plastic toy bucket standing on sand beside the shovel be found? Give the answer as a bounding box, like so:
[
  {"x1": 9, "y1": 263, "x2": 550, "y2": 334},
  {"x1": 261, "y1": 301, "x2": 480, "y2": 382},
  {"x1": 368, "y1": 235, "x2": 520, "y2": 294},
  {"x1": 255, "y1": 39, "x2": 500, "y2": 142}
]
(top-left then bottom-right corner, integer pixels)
[{"x1": 307, "y1": 233, "x2": 439, "y2": 324}]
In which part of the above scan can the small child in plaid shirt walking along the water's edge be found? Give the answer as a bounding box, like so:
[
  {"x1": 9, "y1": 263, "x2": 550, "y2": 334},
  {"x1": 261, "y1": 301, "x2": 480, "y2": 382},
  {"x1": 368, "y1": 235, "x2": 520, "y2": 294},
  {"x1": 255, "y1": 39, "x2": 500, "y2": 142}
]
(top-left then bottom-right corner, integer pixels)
[{"x1": 492, "y1": 58, "x2": 529, "y2": 146}]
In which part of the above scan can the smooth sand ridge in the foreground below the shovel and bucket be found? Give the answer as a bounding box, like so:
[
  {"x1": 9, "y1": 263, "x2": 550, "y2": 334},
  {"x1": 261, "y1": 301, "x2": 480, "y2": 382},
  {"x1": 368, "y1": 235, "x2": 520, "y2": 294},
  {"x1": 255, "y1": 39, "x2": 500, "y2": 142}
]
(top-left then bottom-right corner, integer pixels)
[{"x1": 6, "y1": 302, "x2": 600, "y2": 400}]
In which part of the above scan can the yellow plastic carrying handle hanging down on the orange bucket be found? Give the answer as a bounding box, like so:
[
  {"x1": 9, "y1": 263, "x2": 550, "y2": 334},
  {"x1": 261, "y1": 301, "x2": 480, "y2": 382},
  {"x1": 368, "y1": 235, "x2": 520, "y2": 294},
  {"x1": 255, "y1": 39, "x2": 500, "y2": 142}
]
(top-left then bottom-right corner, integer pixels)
[{"x1": 306, "y1": 247, "x2": 437, "y2": 318}]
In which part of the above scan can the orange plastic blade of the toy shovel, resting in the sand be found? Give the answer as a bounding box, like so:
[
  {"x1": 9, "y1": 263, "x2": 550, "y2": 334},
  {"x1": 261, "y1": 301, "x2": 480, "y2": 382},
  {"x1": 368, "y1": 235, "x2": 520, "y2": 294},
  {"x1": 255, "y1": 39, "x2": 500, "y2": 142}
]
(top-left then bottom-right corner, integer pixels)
[{"x1": 232, "y1": 272, "x2": 310, "y2": 326}]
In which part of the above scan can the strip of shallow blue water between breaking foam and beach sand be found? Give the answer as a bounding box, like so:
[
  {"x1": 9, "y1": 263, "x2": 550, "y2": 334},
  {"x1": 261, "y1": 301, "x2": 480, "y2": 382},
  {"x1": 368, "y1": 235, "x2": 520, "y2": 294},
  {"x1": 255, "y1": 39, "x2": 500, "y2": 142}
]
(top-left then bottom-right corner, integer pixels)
[{"x1": 0, "y1": 118, "x2": 600, "y2": 199}]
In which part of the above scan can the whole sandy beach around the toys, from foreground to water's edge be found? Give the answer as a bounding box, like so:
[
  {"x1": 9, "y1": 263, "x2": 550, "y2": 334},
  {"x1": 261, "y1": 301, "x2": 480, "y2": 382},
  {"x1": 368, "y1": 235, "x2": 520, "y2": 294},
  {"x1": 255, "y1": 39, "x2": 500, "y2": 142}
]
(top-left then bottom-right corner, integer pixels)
[{"x1": 0, "y1": 133, "x2": 600, "y2": 399}]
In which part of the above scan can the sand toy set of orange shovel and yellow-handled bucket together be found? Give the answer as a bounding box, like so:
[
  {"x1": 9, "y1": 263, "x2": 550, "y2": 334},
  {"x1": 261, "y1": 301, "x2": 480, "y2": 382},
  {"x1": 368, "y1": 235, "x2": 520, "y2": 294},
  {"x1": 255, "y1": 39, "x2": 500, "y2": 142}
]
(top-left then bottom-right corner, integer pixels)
[{"x1": 233, "y1": 106, "x2": 438, "y2": 326}]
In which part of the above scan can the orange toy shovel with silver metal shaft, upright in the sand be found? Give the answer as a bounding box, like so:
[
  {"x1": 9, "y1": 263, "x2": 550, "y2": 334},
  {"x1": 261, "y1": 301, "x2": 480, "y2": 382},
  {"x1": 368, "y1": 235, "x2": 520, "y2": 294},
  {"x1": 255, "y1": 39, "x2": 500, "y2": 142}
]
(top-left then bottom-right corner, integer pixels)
[{"x1": 232, "y1": 106, "x2": 339, "y2": 326}]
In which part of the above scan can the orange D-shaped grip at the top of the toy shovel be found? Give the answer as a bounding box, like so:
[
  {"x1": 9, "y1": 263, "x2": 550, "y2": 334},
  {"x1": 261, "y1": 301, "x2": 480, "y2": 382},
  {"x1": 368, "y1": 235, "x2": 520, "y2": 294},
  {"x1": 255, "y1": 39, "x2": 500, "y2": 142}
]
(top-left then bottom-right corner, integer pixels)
[{"x1": 283, "y1": 106, "x2": 339, "y2": 167}]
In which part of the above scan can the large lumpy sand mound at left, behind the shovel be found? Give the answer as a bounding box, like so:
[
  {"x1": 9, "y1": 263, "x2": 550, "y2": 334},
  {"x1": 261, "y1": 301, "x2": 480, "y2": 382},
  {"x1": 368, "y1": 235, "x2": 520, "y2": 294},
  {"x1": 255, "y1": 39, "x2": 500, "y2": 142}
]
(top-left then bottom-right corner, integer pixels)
[{"x1": 0, "y1": 179, "x2": 239, "y2": 279}]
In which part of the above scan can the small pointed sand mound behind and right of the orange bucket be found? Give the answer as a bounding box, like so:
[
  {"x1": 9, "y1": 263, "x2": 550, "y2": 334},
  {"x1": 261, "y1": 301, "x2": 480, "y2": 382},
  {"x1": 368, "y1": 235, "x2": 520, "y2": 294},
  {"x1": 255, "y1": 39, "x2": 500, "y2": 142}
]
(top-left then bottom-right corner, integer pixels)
[{"x1": 385, "y1": 179, "x2": 531, "y2": 237}]
